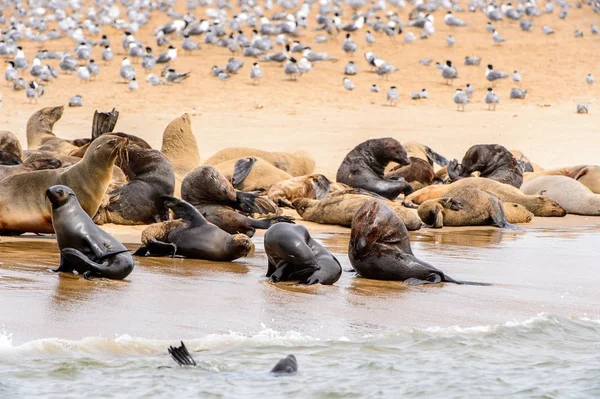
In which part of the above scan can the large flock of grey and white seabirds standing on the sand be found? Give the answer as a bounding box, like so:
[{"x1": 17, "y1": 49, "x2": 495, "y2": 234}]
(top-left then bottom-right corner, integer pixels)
[{"x1": 0, "y1": 0, "x2": 600, "y2": 113}]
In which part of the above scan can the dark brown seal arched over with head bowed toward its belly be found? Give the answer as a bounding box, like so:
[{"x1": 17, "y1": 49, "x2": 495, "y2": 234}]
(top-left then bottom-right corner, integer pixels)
[{"x1": 336, "y1": 137, "x2": 414, "y2": 201}]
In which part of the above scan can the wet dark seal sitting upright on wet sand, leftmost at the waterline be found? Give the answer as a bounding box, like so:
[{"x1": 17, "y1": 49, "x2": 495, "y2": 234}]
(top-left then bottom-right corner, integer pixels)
[{"x1": 46, "y1": 185, "x2": 135, "y2": 280}]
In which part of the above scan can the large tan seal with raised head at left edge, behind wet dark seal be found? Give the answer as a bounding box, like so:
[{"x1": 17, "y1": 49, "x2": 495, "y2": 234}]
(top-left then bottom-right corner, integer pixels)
[{"x1": 0, "y1": 135, "x2": 127, "y2": 234}]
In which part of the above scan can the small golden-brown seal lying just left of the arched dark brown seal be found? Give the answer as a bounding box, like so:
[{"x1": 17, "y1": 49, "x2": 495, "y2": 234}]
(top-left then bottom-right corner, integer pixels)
[{"x1": 267, "y1": 174, "x2": 338, "y2": 208}]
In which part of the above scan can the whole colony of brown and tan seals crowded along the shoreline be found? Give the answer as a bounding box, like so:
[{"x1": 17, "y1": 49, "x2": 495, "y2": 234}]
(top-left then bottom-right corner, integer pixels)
[{"x1": 0, "y1": 107, "x2": 600, "y2": 285}]
